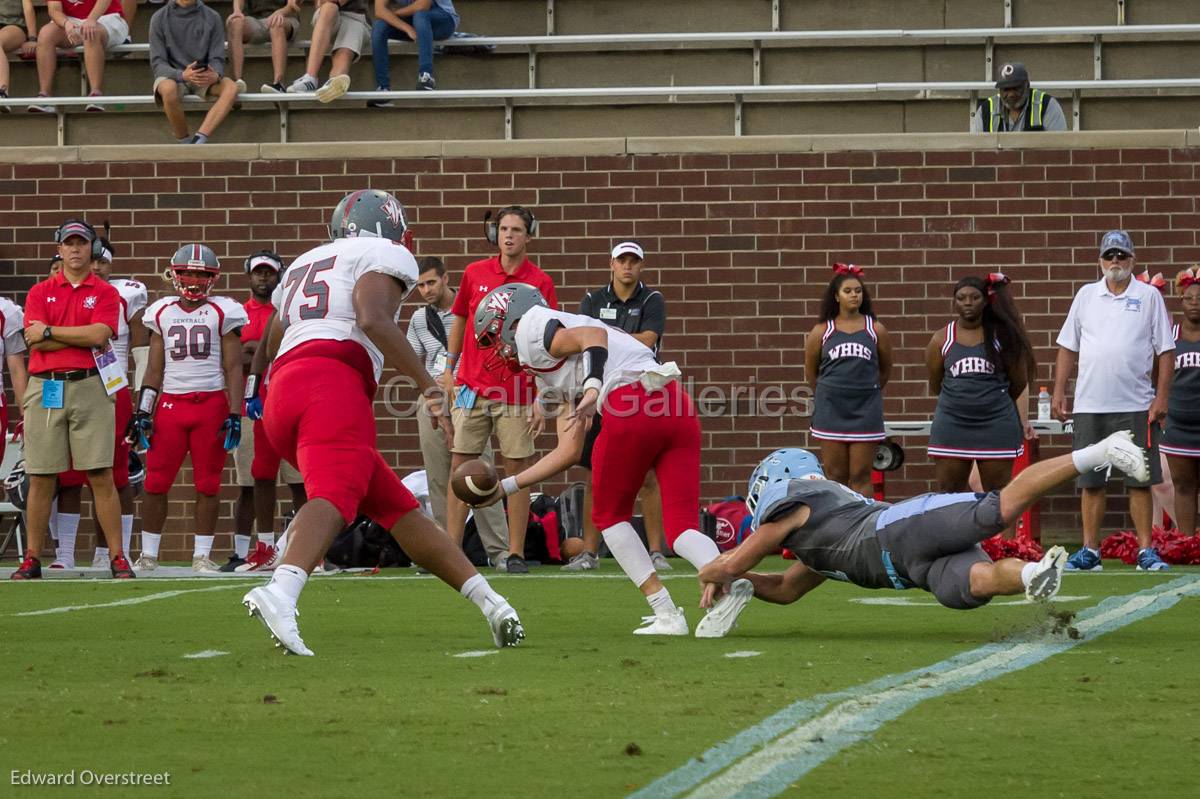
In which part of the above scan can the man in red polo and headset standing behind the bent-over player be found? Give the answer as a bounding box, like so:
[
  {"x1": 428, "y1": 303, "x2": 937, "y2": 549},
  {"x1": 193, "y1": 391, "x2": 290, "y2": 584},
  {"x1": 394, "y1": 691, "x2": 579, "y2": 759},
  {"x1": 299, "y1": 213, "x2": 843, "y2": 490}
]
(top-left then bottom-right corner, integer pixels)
[{"x1": 440, "y1": 205, "x2": 558, "y2": 575}]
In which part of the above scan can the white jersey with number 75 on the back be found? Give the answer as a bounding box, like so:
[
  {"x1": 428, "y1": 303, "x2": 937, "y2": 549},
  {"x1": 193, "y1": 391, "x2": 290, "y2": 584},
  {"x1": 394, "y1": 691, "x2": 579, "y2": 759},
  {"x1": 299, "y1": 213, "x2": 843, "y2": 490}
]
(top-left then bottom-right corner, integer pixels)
[{"x1": 271, "y1": 236, "x2": 418, "y2": 382}]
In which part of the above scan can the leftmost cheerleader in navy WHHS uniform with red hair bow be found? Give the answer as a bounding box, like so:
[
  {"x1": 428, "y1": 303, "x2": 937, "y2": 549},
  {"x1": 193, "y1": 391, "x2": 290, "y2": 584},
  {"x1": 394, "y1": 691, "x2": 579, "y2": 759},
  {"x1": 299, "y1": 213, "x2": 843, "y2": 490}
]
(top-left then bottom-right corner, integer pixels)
[{"x1": 804, "y1": 264, "x2": 892, "y2": 495}]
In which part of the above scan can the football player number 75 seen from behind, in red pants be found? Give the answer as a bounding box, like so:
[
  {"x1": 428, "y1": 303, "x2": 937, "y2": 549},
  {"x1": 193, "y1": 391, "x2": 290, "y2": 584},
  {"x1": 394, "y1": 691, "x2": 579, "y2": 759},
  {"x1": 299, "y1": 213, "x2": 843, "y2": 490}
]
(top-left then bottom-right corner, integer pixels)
[{"x1": 242, "y1": 190, "x2": 524, "y2": 655}]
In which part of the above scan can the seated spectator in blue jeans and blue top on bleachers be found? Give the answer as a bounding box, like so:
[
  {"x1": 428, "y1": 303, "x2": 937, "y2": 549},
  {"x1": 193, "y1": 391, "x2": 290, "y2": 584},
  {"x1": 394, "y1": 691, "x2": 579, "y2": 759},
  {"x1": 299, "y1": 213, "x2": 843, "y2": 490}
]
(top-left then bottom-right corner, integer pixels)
[{"x1": 368, "y1": 0, "x2": 458, "y2": 102}]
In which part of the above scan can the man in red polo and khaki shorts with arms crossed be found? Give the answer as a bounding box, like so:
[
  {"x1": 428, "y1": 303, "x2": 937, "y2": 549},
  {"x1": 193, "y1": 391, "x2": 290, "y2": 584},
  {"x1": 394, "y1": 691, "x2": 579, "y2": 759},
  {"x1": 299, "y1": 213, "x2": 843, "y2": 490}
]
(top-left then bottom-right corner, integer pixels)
[{"x1": 12, "y1": 220, "x2": 133, "y2": 579}]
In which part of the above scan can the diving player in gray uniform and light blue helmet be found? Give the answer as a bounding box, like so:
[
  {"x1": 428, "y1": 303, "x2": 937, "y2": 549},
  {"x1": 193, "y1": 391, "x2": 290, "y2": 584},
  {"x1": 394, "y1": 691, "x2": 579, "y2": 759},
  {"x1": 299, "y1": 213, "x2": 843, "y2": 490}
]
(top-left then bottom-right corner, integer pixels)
[{"x1": 700, "y1": 431, "x2": 1150, "y2": 626}]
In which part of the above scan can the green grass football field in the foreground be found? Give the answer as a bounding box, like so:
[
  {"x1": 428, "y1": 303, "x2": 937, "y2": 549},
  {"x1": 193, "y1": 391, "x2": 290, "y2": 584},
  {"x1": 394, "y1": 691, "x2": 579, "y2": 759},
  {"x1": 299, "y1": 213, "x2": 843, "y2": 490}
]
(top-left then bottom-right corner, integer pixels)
[{"x1": 0, "y1": 560, "x2": 1200, "y2": 799}]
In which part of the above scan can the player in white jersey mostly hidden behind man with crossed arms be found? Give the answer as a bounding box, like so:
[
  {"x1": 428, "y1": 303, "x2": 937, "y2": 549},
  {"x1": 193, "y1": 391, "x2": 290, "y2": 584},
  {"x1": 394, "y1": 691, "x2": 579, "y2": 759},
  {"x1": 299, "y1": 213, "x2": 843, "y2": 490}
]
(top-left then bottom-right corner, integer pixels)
[{"x1": 50, "y1": 233, "x2": 150, "y2": 570}]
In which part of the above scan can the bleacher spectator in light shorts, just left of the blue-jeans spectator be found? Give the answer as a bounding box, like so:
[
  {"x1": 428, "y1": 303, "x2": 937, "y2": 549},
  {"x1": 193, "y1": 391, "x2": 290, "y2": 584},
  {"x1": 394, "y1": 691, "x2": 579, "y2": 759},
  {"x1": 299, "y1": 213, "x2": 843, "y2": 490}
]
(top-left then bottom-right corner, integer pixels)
[{"x1": 288, "y1": 0, "x2": 371, "y2": 103}]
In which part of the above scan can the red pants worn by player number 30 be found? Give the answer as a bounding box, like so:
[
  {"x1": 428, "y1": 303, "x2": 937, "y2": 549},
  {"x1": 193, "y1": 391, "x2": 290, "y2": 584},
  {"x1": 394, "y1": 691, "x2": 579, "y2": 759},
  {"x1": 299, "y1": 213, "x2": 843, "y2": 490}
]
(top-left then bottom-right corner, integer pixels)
[{"x1": 146, "y1": 391, "x2": 229, "y2": 497}]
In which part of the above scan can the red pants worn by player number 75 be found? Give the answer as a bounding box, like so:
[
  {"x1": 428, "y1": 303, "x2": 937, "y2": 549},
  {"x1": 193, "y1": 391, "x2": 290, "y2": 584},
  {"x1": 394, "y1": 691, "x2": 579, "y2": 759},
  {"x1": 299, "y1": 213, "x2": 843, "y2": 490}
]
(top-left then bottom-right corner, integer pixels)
[{"x1": 264, "y1": 341, "x2": 419, "y2": 530}]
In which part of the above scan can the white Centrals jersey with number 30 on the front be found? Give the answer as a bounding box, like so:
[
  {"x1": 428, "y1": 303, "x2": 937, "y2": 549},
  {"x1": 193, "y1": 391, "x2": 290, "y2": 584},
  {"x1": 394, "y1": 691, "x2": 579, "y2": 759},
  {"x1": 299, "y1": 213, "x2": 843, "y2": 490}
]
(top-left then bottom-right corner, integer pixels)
[{"x1": 142, "y1": 296, "x2": 250, "y2": 394}]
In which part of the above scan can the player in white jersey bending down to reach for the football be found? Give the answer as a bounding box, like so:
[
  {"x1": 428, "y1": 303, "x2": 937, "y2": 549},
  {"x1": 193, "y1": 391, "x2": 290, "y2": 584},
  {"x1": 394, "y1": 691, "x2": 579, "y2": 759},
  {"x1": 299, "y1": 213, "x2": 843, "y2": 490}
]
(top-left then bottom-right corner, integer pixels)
[{"x1": 474, "y1": 283, "x2": 754, "y2": 638}]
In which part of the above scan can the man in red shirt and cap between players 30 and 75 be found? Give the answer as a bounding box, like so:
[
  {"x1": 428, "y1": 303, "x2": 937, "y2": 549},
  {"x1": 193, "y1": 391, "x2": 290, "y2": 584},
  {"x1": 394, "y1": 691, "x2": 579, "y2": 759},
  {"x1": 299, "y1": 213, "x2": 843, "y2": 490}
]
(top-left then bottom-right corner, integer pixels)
[{"x1": 221, "y1": 250, "x2": 307, "y2": 571}]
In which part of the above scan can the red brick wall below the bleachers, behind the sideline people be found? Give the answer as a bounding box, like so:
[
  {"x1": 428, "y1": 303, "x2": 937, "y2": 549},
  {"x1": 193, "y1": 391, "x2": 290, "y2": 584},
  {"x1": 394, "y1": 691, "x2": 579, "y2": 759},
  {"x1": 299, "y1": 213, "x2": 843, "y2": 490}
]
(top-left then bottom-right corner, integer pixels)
[{"x1": 0, "y1": 139, "x2": 1200, "y2": 554}]
